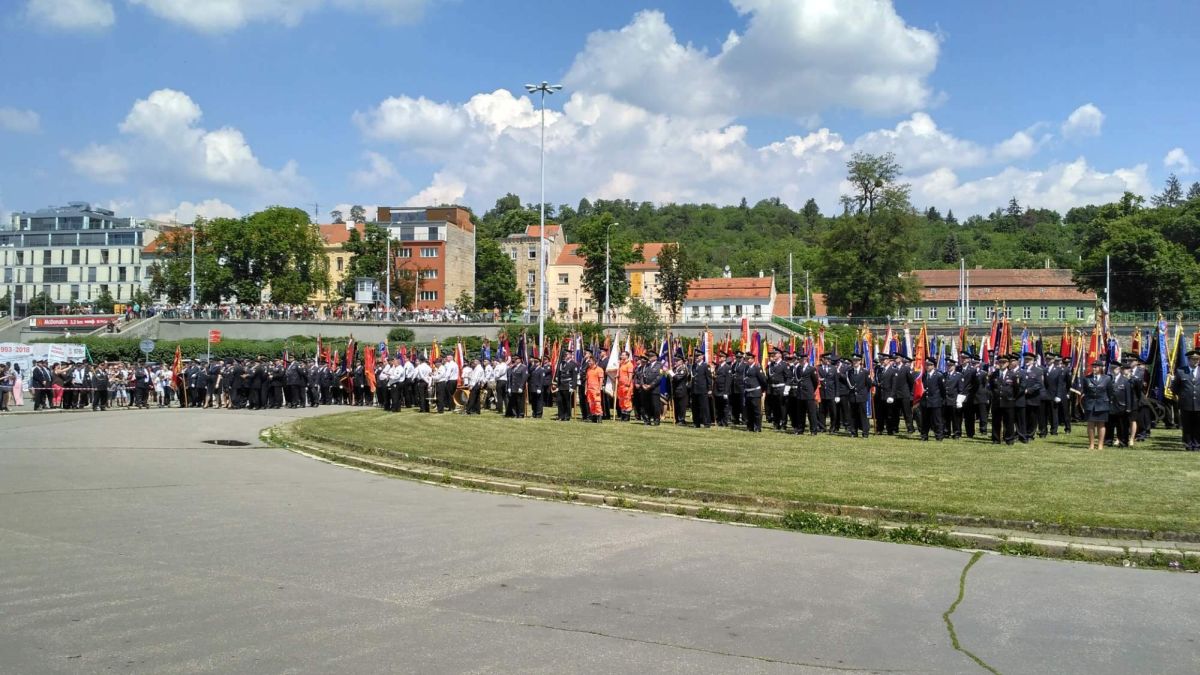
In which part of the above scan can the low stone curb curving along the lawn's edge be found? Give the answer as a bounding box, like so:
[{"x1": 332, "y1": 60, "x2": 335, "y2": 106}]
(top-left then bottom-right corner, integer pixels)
[{"x1": 270, "y1": 428, "x2": 1200, "y2": 567}]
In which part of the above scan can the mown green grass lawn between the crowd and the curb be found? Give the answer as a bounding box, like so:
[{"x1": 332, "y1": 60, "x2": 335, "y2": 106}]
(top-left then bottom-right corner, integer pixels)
[{"x1": 294, "y1": 411, "x2": 1200, "y2": 532}]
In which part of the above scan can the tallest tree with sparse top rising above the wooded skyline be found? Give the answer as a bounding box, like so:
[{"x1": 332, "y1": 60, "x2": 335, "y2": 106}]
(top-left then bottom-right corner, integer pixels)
[{"x1": 816, "y1": 153, "x2": 919, "y2": 316}]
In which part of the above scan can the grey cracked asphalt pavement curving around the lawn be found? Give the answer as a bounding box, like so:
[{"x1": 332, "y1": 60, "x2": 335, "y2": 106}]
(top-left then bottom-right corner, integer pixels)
[{"x1": 0, "y1": 408, "x2": 1200, "y2": 674}]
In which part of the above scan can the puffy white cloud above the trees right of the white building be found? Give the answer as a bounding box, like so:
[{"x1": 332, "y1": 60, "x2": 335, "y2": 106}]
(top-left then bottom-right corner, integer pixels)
[{"x1": 70, "y1": 89, "x2": 305, "y2": 203}]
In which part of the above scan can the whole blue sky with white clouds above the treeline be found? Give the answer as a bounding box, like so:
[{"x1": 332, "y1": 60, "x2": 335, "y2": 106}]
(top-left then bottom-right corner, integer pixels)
[{"x1": 0, "y1": 0, "x2": 1200, "y2": 221}]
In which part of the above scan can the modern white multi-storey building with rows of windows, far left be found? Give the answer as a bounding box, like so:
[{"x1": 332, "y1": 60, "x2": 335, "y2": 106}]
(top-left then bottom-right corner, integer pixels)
[{"x1": 0, "y1": 202, "x2": 157, "y2": 306}]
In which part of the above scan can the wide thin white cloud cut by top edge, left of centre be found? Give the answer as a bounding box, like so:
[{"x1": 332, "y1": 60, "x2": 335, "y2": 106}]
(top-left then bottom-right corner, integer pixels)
[{"x1": 130, "y1": 0, "x2": 428, "y2": 32}]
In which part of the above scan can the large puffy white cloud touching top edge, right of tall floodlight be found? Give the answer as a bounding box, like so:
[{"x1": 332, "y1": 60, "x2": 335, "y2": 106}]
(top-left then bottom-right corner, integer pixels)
[{"x1": 565, "y1": 0, "x2": 940, "y2": 119}]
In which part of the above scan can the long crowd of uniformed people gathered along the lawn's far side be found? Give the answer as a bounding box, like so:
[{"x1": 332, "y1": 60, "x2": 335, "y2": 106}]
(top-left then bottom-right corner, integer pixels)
[{"x1": 0, "y1": 348, "x2": 1200, "y2": 450}]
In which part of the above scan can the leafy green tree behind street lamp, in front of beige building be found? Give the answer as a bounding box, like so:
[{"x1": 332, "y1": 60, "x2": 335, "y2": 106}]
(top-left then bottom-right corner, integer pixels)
[{"x1": 575, "y1": 214, "x2": 642, "y2": 322}]
